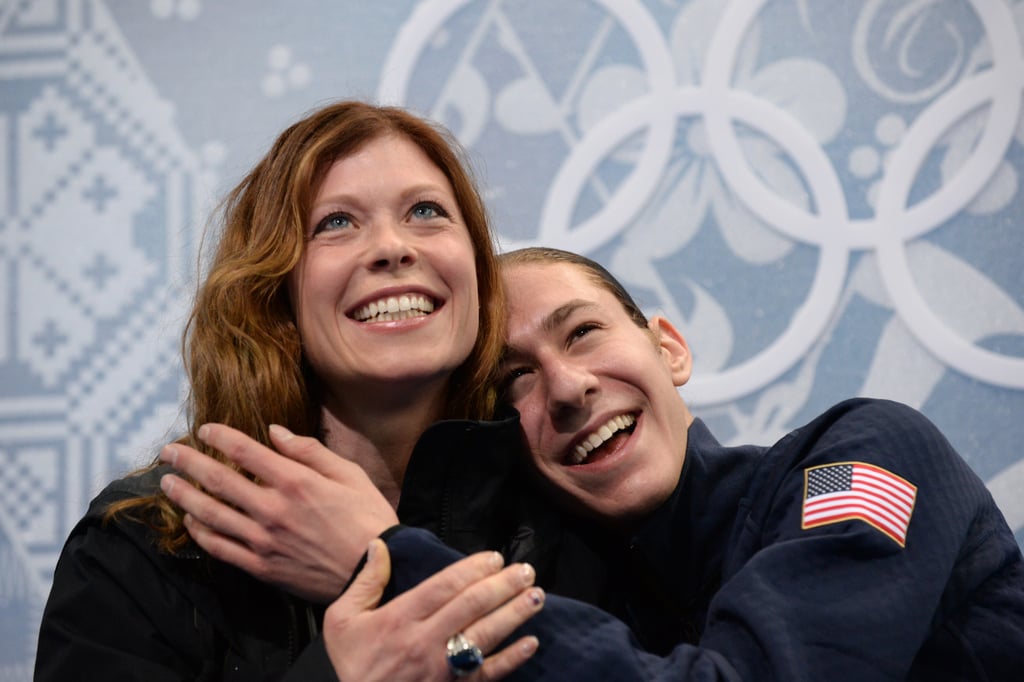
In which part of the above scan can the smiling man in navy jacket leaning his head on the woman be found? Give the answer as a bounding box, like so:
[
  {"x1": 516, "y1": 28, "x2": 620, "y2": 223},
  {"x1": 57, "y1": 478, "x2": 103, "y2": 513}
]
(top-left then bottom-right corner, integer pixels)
[{"x1": 500, "y1": 248, "x2": 1024, "y2": 681}]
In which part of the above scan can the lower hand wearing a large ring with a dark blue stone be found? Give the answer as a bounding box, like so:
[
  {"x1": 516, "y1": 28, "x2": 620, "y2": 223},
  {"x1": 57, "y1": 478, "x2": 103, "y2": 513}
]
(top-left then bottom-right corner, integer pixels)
[{"x1": 324, "y1": 540, "x2": 544, "y2": 682}]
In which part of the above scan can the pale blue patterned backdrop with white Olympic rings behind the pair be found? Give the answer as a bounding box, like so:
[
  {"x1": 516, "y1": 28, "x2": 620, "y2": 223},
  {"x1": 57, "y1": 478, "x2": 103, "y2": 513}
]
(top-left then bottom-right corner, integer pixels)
[{"x1": 0, "y1": 0, "x2": 1024, "y2": 681}]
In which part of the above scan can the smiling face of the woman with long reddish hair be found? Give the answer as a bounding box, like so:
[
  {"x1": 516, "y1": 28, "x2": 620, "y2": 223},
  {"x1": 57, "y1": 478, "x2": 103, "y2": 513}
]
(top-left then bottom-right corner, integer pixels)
[{"x1": 289, "y1": 135, "x2": 479, "y2": 400}]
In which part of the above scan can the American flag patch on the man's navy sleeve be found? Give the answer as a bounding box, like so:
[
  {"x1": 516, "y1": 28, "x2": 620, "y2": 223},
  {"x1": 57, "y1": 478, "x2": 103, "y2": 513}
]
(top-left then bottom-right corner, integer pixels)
[{"x1": 801, "y1": 462, "x2": 918, "y2": 547}]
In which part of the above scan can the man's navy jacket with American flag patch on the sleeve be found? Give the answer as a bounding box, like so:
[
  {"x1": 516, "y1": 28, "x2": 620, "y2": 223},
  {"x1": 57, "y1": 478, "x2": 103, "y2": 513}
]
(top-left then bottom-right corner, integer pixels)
[{"x1": 388, "y1": 399, "x2": 1024, "y2": 682}]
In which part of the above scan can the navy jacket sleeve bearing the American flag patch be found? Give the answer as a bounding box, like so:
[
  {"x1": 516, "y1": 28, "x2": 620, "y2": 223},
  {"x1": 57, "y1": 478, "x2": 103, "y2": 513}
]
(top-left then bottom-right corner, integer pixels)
[{"x1": 688, "y1": 400, "x2": 1024, "y2": 682}]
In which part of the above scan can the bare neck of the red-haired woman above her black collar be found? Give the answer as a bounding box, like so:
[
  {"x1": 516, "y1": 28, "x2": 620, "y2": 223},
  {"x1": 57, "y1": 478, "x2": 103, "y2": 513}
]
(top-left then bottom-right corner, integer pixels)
[{"x1": 322, "y1": 382, "x2": 444, "y2": 508}]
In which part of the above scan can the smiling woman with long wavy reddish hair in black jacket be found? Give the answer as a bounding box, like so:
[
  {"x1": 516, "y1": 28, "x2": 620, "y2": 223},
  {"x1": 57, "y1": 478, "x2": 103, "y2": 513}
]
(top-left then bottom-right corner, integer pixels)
[{"x1": 36, "y1": 102, "x2": 543, "y2": 680}]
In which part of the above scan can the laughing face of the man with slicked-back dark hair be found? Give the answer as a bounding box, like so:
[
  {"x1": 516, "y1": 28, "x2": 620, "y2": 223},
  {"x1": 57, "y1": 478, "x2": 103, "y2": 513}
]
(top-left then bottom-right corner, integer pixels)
[{"x1": 501, "y1": 263, "x2": 692, "y2": 523}]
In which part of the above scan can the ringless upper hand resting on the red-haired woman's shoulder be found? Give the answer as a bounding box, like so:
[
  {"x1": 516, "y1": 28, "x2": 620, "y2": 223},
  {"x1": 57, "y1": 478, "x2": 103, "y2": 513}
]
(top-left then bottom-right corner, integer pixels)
[{"x1": 160, "y1": 424, "x2": 398, "y2": 603}]
